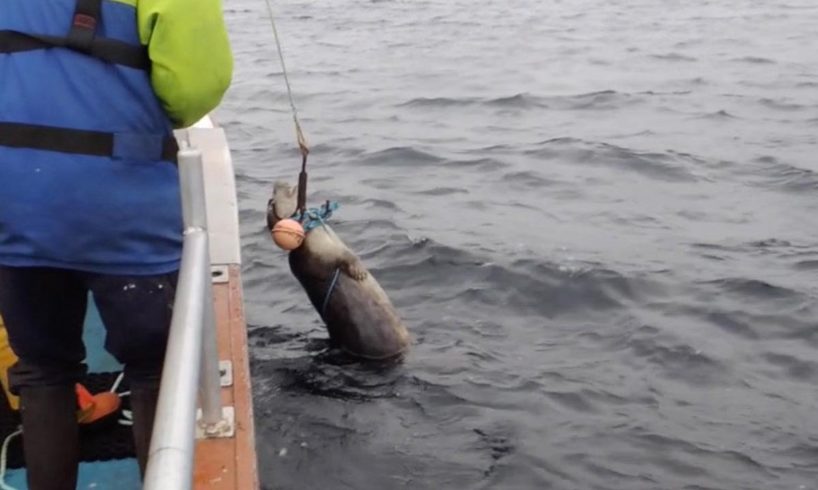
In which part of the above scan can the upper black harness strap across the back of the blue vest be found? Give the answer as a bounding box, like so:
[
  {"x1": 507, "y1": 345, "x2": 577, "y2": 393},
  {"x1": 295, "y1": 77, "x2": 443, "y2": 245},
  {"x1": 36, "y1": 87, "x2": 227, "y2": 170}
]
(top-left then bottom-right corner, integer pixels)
[{"x1": 0, "y1": 0, "x2": 151, "y2": 71}]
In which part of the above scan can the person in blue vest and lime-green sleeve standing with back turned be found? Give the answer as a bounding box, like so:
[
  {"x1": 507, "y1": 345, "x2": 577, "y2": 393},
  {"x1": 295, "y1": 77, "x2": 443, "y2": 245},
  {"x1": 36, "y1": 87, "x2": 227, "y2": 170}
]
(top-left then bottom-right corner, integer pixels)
[{"x1": 0, "y1": 0, "x2": 233, "y2": 490}]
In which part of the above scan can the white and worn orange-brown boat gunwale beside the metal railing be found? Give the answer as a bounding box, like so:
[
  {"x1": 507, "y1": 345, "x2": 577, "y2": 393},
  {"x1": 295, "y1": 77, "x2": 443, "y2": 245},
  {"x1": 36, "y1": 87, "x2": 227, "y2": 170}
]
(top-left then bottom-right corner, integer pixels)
[{"x1": 180, "y1": 118, "x2": 258, "y2": 490}]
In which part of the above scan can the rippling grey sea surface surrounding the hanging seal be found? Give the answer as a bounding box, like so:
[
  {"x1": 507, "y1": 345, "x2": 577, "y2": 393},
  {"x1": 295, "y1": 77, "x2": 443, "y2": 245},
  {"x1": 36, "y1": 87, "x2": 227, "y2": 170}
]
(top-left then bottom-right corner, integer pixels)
[{"x1": 215, "y1": 0, "x2": 818, "y2": 490}]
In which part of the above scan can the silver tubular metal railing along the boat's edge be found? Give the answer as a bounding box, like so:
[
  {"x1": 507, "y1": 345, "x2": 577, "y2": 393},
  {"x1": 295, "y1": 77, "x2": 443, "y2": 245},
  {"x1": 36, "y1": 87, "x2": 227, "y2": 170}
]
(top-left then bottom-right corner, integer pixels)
[{"x1": 143, "y1": 145, "x2": 232, "y2": 490}]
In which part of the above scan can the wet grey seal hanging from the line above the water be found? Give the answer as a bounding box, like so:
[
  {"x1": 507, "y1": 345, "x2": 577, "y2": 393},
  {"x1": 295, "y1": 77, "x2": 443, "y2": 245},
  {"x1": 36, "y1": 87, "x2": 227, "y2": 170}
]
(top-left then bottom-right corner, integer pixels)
[{"x1": 267, "y1": 181, "x2": 410, "y2": 360}]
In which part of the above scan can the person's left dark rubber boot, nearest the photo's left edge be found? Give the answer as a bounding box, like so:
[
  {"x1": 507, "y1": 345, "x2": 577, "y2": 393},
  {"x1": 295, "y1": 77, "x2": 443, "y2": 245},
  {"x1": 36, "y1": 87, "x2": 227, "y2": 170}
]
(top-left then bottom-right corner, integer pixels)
[{"x1": 20, "y1": 384, "x2": 80, "y2": 490}]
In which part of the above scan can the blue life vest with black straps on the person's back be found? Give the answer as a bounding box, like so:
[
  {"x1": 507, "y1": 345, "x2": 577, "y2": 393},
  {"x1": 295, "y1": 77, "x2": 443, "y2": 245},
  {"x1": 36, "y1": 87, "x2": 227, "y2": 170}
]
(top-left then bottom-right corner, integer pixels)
[{"x1": 0, "y1": 0, "x2": 182, "y2": 274}]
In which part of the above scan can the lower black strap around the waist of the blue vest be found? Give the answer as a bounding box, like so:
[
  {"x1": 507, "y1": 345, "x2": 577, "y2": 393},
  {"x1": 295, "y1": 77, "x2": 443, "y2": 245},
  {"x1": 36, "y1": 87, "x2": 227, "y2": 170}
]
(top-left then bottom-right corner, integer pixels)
[{"x1": 0, "y1": 122, "x2": 179, "y2": 162}]
